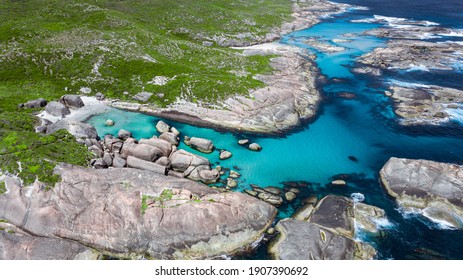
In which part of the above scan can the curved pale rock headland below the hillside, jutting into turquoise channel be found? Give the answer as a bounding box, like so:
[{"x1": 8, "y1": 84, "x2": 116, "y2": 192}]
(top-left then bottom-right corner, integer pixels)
[{"x1": 112, "y1": 45, "x2": 320, "y2": 134}]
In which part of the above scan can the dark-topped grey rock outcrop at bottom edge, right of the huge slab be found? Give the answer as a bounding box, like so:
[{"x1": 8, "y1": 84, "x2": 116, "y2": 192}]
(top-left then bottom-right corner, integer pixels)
[{"x1": 269, "y1": 195, "x2": 385, "y2": 260}]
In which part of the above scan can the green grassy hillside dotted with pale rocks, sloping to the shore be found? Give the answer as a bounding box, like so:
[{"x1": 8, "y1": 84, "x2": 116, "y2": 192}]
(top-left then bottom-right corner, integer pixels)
[{"x1": 0, "y1": 0, "x2": 291, "y2": 186}]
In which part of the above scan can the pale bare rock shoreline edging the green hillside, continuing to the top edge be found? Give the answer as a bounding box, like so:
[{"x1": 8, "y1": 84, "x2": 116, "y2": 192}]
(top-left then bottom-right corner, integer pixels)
[{"x1": 111, "y1": 1, "x2": 353, "y2": 134}]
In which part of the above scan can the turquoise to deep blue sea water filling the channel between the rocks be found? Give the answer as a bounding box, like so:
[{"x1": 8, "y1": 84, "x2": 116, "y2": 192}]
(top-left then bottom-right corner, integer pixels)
[{"x1": 89, "y1": 0, "x2": 463, "y2": 259}]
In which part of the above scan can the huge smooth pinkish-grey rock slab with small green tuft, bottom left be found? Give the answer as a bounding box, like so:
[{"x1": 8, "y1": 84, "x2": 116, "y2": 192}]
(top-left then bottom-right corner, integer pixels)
[{"x1": 0, "y1": 166, "x2": 276, "y2": 259}]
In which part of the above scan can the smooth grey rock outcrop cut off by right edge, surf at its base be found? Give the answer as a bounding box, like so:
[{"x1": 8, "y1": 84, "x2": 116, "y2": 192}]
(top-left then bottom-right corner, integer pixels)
[{"x1": 380, "y1": 157, "x2": 463, "y2": 228}]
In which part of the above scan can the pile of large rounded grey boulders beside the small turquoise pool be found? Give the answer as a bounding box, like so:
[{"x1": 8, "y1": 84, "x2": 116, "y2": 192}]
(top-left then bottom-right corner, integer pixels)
[{"x1": 90, "y1": 121, "x2": 220, "y2": 184}]
